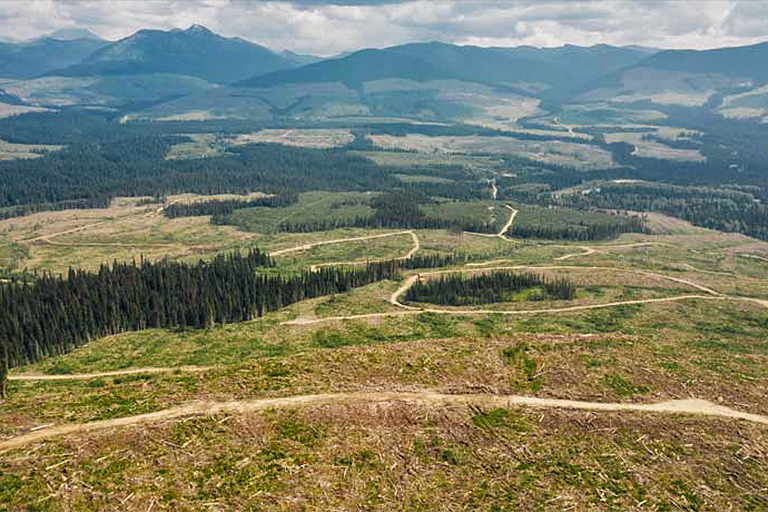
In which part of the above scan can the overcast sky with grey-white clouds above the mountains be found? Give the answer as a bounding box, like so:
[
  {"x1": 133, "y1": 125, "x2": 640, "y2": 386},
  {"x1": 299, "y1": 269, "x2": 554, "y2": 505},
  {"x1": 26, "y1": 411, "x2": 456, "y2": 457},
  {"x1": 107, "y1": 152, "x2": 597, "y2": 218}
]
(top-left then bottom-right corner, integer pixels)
[{"x1": 0, "y1": 0, "x2": 768, "y2": 56}]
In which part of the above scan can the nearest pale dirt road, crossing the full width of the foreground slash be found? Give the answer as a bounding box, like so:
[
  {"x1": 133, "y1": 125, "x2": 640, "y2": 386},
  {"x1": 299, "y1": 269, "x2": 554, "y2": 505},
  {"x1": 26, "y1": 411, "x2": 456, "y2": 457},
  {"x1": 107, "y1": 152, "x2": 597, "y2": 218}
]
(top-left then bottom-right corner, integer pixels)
[{"x1": 0, "y1": 391, "x2": 768, "y2": 452}]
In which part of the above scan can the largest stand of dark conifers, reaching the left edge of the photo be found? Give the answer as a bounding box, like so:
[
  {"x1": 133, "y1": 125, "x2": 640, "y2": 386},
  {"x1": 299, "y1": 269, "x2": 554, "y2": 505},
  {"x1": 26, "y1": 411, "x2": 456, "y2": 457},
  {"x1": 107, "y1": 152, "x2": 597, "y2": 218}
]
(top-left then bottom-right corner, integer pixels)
[{"x1": 0, "y1": 250, "x2": 400, "y2": 366}]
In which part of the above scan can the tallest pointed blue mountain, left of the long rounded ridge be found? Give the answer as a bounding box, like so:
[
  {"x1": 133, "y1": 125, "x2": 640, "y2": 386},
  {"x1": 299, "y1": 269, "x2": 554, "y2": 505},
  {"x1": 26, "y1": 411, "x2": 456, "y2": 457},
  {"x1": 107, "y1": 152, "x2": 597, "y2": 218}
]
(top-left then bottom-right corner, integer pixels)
[{"x1": 50, "y1": 25, "x2": 310, "y2": 83}]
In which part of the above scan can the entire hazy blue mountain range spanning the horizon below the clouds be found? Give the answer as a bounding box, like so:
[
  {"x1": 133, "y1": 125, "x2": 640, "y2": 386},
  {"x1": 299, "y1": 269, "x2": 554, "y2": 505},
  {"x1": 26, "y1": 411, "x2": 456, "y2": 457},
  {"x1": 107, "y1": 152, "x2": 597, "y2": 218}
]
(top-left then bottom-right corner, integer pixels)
[{"x1": 0, "y1": 25, "x2": 768, "y2": 126}]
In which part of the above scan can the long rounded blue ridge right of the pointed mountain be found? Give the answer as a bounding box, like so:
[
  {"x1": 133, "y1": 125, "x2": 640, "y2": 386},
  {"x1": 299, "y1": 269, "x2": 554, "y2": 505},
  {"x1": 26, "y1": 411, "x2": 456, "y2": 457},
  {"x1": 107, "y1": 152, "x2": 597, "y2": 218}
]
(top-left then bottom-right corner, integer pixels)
[{"x1": 235, "y1": 42, "x2": 648, "y2": 98}]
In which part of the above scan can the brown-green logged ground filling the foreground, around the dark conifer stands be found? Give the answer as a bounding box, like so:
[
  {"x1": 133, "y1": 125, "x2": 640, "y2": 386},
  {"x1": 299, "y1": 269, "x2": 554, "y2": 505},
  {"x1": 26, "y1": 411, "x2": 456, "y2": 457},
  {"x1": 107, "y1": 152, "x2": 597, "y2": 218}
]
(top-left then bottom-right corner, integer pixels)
[{"x1": 0, "y1": 193, "x2": 768, "y2": 510}]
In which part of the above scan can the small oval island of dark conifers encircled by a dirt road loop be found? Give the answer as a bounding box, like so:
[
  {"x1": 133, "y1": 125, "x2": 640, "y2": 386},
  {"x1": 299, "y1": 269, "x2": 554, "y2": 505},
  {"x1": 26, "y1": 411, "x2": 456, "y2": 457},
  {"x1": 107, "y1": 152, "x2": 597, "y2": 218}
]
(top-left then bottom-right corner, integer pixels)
[{"x1": 405, "y1": 271, "x2": 576, "y2": 306}]
